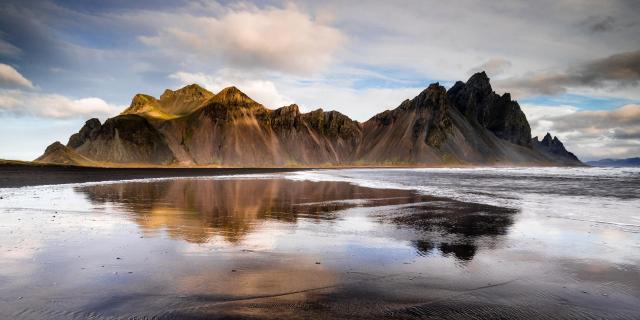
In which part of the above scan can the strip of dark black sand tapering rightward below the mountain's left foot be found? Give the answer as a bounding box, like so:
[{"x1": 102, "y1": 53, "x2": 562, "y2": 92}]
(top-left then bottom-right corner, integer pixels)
[{"x1": 0, "y1": 163, "x2": 305, "y2": 188}]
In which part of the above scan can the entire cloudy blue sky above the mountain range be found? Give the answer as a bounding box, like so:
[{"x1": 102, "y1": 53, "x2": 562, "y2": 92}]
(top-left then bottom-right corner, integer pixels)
[{"x1": 0, "y1": 0, "x2": 640, "y2": 160}]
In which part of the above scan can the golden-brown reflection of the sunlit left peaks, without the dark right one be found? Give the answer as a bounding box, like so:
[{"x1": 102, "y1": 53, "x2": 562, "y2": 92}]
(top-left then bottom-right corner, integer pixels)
[{"x1": 75, "y1": 179, "x2": 426, "y2": 243}]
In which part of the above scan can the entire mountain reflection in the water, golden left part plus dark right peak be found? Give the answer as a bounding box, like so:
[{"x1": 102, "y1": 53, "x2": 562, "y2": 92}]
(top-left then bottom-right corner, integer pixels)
[{"x1": 75, "y1": 179, "x2": 515, "y2": 261}]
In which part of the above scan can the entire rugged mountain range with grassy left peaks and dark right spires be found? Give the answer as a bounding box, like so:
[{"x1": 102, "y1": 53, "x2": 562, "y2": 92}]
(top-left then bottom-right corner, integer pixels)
[{"x1": 36, "y1": 72, "x2": 582, "y2": 167}]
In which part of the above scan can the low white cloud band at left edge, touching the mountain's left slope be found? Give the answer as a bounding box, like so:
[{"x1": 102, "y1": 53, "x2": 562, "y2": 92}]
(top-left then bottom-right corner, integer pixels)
[{"x1": 0, "y1": 90, "x2": 124, "y2": 119}]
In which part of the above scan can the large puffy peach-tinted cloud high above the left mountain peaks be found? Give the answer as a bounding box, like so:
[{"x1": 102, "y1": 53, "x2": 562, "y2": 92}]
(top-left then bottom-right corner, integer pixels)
[{"x1": 139, "y1": 5, "x2": 345, "y2": 74}]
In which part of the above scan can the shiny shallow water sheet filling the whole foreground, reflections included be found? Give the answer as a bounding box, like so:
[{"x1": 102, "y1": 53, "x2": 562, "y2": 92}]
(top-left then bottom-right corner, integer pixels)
[{"x1": 0, "y1": 168, "x2": 640, "y2": 319}]
